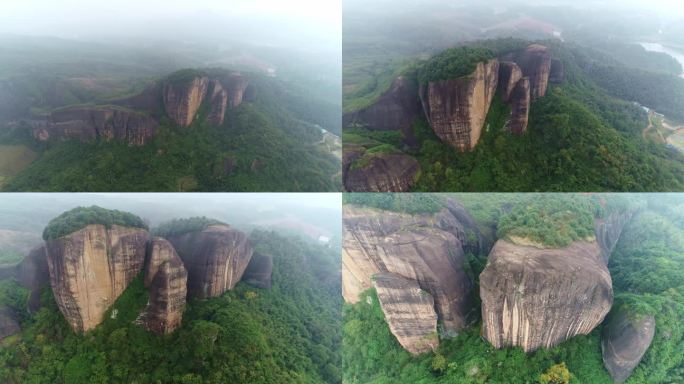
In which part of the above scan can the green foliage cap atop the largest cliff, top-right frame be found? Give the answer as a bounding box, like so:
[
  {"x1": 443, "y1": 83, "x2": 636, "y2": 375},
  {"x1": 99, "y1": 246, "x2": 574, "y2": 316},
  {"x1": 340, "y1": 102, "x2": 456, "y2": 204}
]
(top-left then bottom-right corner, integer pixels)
[{"x1": 418, "y1": 46, "x2": 495, "y2": 83}]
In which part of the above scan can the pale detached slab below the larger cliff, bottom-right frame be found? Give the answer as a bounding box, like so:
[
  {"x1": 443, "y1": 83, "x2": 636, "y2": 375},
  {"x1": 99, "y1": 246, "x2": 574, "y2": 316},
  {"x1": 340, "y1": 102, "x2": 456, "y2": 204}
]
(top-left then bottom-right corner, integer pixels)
[{"x1": 373, "y1": 273, "x2": 439, "y2": 354}]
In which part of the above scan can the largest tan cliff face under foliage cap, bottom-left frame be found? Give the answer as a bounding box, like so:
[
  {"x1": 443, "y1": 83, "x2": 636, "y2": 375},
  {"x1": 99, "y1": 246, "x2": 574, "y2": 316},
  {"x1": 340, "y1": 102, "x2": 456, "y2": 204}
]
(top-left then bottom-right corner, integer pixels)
[{"x1": 46, "y1": 225, "x2": 148, "y2": 332}]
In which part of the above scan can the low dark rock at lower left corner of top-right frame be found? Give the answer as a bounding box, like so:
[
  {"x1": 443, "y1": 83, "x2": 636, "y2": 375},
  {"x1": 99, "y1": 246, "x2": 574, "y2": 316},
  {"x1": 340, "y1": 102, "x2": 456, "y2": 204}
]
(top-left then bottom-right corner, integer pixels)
[{"x1": 342, "y1": 147, "x2": 420, "y2": 192}]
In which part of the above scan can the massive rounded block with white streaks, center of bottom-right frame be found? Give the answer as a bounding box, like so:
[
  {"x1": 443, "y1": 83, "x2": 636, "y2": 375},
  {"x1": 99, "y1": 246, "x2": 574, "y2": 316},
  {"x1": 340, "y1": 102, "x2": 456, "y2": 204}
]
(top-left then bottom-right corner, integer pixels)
[{"x1": 480, "y1": 240, "x2": 613, "y2": 352}]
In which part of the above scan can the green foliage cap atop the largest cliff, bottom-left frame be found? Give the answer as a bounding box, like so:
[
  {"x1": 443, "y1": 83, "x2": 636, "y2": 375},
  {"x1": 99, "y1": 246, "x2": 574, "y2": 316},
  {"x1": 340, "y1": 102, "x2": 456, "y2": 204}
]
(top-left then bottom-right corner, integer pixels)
[{"x1": 43, "y1": 205, "x2": 147, "y2": 240}]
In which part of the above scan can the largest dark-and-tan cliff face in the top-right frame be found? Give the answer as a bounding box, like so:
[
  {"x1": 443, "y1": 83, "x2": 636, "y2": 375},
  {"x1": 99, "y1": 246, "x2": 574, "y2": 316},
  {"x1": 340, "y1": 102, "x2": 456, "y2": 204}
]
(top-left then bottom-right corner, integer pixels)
[{"x1": 420, "y1": 59, "x2": 499, "y2": 151}]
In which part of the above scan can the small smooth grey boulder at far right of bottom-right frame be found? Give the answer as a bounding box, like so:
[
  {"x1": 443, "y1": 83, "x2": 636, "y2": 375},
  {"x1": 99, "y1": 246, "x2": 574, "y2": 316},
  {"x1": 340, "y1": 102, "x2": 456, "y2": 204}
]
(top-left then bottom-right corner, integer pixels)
[{"x1": 601, "y1": 309, "x2": 656, "y2": 383}]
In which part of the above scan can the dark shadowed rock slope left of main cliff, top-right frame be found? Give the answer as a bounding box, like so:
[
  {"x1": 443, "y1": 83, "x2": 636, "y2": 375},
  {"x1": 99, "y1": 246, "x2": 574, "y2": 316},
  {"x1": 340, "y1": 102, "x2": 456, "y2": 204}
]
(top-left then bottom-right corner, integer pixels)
[{"x1": 343, "y1": 76, "x2": 421, "y2": 133}]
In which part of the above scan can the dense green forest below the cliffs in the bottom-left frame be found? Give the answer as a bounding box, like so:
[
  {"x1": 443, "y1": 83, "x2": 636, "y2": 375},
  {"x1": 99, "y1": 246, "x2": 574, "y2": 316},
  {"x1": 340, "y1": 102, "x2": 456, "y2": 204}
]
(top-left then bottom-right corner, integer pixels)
[{"x1": 0, "y1": 232, "x2": 341, "y2": 384}]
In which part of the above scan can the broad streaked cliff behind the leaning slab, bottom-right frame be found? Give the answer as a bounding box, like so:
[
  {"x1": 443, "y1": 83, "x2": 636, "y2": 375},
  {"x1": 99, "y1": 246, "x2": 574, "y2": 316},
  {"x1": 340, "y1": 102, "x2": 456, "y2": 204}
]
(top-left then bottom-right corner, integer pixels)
[{"x1": 342, "y1": 205, "x2": 472, "y2": 332}]
